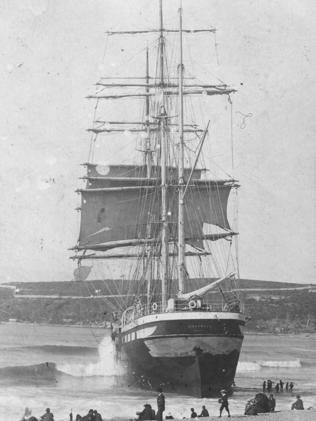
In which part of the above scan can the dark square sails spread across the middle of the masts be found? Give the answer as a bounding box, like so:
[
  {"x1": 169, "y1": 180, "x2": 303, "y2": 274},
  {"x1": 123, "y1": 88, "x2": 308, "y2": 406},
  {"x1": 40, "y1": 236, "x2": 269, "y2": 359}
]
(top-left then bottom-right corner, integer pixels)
[{"x1": 78, "y1": 165, "x2": 234, "y2": 251}]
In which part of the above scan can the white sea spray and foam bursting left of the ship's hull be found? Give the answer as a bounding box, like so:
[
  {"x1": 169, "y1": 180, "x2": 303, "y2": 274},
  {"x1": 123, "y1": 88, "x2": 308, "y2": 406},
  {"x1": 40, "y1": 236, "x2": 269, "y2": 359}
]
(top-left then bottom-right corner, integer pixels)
[{"x1": 57, "y1": 337, "x2": 125, "y2": 377}]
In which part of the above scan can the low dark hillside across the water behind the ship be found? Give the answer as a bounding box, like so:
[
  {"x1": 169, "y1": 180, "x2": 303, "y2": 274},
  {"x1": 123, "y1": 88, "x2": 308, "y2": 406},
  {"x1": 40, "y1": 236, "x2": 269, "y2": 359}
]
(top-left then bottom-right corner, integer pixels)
[{"x1": 0, "y1": 280, "x2": 316, "y2": 333}]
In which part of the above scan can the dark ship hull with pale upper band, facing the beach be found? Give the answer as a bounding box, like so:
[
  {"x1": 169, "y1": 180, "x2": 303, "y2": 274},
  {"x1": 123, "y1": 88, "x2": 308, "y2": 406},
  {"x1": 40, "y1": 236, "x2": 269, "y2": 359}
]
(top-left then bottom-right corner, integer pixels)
[{"x1": 118, "y1": 312, "x2": 244, "y2": 397}]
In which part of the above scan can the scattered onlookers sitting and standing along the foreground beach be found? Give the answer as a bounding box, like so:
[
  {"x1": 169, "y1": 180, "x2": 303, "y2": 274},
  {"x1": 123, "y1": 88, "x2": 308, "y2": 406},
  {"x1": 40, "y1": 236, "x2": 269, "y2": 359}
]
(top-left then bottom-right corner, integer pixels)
[{"x1": 21, "y1": 380, "x2": 310, "y2": 421}]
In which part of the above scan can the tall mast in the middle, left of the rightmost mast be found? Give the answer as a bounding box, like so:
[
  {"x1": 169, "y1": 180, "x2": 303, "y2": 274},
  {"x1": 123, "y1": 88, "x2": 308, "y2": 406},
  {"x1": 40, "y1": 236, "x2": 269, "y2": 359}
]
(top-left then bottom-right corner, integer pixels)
[{"x1": 159, "y1": 0, "x2": 169, "y2": 311}]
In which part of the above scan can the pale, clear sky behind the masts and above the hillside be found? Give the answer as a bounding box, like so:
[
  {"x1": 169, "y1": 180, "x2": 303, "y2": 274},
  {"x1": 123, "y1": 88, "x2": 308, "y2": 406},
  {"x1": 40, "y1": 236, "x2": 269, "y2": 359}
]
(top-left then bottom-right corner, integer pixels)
[{"x1": 0, "y1": 0, "x2": 316, "y2": 283}]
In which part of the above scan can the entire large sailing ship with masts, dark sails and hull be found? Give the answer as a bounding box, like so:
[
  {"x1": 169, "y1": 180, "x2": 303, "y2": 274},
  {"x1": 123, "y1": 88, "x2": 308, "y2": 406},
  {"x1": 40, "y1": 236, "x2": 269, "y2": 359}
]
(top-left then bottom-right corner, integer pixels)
[{"x1": 76, "y1": 0, "x2": 245, "y2": 397}]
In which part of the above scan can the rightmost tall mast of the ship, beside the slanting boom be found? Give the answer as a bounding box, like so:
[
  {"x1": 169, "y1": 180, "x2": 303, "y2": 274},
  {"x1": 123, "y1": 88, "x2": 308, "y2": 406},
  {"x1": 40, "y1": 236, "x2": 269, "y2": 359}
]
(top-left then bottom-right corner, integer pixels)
[{"x1": 178, "y1": 1, "x2": 185, "y2": 294}]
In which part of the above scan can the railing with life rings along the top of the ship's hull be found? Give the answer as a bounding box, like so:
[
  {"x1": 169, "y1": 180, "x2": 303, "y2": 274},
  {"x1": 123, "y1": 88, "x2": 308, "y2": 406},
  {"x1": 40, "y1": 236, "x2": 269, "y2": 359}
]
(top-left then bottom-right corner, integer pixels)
[{"x1": 122, "y1": 300, "x2": 241, "y2": 326}]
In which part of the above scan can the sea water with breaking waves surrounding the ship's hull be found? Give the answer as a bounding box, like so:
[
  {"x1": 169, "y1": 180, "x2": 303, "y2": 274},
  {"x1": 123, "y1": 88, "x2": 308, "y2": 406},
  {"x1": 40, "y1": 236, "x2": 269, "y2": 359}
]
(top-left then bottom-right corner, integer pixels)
[{"x1": 0, "y1": 323, "x2": 316, "y2": 421}]
